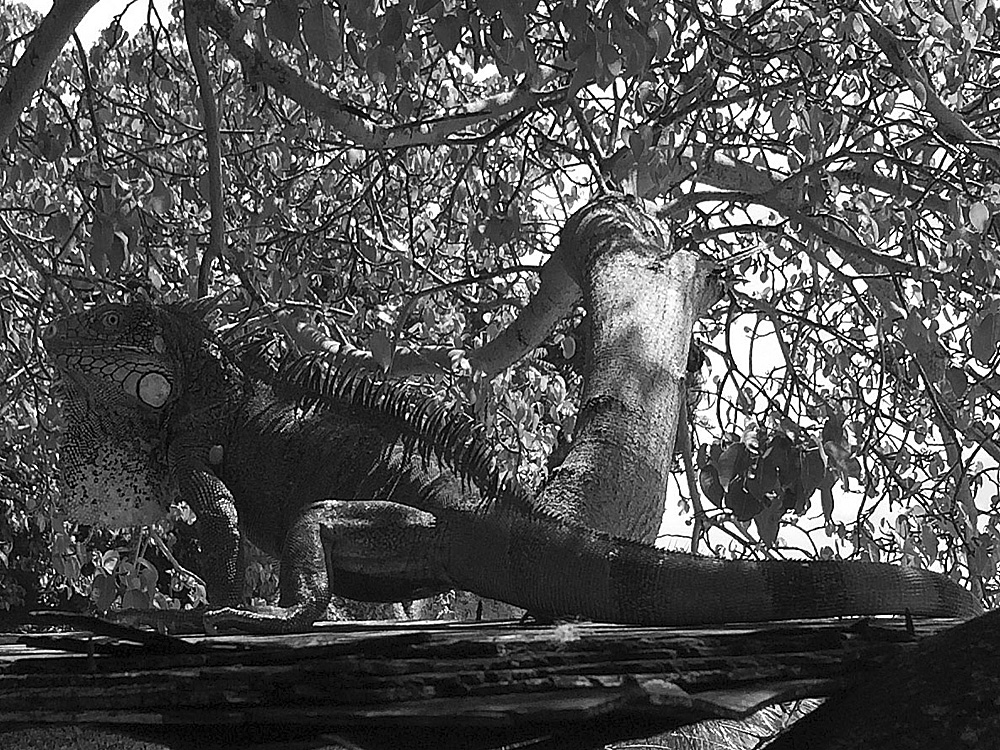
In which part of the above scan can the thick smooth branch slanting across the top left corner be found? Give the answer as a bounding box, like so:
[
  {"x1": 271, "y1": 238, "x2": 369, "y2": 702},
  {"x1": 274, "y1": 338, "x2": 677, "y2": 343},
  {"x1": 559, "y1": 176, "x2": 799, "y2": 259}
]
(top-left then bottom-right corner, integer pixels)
[{"x1": 0, "y1": 0, "x2": 97, "y2": 144}]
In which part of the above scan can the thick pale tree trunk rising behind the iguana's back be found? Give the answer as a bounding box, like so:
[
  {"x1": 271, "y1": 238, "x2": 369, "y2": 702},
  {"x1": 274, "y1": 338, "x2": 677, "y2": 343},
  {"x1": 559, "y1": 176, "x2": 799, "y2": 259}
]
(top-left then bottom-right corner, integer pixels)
[{"x1": 540, "y1": 197, "x2": 714, "y2": 543}]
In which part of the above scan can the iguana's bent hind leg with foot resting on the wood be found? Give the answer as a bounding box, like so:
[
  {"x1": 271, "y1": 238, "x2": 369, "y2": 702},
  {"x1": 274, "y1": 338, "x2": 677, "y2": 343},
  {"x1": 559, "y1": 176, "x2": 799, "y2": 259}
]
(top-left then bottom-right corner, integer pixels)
[{"x1": 205, "y1": 500, "x2": 450, "y2": 633}]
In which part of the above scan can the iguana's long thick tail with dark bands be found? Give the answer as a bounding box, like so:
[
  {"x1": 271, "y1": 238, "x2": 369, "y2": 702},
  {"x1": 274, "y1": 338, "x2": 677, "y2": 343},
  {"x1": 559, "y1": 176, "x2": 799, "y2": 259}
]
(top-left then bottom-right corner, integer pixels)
[{"x1": 438, "y1": 510, "x2": 982, "y2": 625}]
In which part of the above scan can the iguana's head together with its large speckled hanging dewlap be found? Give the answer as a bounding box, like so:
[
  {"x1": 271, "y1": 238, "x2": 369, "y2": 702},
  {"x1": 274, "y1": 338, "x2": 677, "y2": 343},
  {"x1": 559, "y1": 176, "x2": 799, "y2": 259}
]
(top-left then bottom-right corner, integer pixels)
[{"x1": 45, "y1": 298, "x2": 214, "y2": 527}]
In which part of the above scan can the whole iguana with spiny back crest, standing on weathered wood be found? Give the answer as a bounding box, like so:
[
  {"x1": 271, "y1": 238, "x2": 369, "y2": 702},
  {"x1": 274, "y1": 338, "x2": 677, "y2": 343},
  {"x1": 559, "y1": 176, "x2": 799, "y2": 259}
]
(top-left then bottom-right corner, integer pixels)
[{"x1": 46, "y1": 228, "x2": 977, "y2": 632}]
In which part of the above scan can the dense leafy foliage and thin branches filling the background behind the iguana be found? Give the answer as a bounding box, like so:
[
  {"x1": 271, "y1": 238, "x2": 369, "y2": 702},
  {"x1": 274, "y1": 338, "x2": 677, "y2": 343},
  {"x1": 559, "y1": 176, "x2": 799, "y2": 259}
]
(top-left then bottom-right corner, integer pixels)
[{"x1": 0, "y1": 0, "x2": 1000, "y2": 616}]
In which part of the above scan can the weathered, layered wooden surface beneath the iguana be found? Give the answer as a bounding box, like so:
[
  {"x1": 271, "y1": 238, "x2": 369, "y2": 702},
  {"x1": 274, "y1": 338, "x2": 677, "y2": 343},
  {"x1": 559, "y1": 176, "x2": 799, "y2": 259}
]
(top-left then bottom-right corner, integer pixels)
[{"x1": 0, "y1": 620, "x2": 968, "y2": 734}]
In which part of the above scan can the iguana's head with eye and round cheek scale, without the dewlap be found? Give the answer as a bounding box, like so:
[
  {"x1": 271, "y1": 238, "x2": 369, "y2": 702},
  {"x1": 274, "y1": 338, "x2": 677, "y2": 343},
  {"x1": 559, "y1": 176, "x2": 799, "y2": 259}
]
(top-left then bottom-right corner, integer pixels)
[{"x1": 45, "y1": 300, "x2": 180, "y2": 411}]
